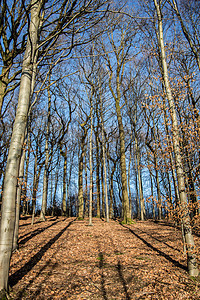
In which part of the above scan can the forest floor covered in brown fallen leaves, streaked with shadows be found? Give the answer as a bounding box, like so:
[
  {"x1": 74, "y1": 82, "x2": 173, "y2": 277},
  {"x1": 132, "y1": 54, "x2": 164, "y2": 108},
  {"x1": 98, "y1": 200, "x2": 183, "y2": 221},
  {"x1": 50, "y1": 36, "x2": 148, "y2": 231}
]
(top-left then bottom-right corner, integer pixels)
[{"x1": 9, "y1": 217, "x2": 200, "y2": 300}]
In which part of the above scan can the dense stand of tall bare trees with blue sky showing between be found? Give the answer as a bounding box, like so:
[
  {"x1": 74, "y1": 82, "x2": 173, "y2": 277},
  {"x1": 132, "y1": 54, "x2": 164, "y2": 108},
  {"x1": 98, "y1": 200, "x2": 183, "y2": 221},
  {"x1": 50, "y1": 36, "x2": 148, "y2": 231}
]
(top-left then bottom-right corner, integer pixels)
[{"x1": 0, "y1": 0, "x2": 200, "y2": 291}]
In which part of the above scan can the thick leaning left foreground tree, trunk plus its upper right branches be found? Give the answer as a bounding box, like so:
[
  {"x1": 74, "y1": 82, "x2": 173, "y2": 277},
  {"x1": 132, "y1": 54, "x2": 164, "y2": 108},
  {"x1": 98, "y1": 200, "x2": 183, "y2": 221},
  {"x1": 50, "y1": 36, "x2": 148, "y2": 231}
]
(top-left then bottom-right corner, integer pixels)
[{"x1": 0, "y1": 0, "x2": 109, "y2": 293}]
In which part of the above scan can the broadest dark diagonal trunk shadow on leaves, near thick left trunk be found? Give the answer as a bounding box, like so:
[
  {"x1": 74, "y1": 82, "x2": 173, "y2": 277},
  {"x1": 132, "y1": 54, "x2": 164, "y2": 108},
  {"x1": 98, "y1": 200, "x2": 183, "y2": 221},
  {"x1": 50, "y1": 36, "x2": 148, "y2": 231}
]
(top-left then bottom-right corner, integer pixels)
[{"x1": 9, "y1": 220, "x2": 74, "y2": 287}]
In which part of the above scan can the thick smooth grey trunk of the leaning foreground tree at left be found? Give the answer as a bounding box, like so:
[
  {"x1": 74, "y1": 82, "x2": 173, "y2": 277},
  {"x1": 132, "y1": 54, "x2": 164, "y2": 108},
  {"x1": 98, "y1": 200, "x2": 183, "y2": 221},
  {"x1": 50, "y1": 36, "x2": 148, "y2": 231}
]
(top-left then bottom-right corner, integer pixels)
[{"x1": 0, "y1": 0, "x2": 42, "y2": 291}]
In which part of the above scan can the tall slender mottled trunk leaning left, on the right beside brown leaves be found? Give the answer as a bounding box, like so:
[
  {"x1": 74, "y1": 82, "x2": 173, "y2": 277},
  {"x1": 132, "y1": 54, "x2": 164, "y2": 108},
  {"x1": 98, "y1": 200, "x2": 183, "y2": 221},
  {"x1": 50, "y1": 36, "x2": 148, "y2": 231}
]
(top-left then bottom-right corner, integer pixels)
[{"x1": 154, "y1": 0, "x2": 199, "y2": 276}]
